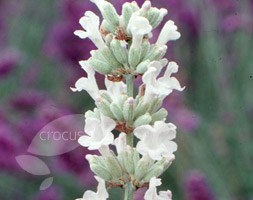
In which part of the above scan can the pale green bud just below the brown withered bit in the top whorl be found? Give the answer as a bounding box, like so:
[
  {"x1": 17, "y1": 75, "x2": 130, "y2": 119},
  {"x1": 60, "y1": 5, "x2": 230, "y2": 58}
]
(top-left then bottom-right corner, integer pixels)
[{"x1": 111, "y1": 39, "x2": 127, "y2": 64}]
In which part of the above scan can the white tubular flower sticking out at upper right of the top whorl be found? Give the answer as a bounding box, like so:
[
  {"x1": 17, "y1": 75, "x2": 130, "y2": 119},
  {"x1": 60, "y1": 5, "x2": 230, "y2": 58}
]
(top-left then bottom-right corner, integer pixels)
[{"x1": 156, "y1": 20, "x2": 181, "y2": 46}]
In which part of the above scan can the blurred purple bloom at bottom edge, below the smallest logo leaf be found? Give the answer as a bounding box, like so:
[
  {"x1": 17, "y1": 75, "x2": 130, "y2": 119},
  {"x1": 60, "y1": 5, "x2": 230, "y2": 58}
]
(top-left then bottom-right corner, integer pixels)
[{"x1": 33, "y1": 186, "x2": 63, "y2": 200}]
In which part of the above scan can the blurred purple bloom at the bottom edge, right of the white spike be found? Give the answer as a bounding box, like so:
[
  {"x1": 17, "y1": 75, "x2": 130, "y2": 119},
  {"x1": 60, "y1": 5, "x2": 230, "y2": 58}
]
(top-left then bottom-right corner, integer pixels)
[{"x1": 186, "y1": 171, "x2": 216, "y2": 200}]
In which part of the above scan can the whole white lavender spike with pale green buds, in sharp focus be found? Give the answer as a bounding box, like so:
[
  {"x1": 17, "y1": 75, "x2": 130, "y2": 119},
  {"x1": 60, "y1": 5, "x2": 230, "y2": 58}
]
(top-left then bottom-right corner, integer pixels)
[{"x1": 71, "y1": 0, "x2": 184, "y2": 200}]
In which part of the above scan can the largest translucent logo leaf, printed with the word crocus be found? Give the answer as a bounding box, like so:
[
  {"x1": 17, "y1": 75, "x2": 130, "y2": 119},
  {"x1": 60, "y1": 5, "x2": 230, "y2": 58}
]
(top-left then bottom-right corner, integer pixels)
[{"x1": 27, "y1": 114, "x2": 84, "y2": 156}]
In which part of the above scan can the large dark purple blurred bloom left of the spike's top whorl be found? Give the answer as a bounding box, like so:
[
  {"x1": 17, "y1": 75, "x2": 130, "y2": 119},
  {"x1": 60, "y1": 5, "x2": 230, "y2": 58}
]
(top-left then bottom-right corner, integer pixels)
[{"x1": 45, "y1": 0, "x2": 94, "y2": 67}]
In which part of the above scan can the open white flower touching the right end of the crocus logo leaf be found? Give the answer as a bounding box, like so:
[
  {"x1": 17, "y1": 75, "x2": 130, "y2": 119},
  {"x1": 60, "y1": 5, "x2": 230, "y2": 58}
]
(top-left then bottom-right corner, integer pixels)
[{"x1": 78, "y1": 114, "x2": 116, "y2": 150}]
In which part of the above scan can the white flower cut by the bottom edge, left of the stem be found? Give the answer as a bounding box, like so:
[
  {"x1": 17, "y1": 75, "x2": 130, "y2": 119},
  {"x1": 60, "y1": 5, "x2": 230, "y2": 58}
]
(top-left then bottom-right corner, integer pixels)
[{"x1": 82, "y1": 176, "x2": 109, "y2": 200}]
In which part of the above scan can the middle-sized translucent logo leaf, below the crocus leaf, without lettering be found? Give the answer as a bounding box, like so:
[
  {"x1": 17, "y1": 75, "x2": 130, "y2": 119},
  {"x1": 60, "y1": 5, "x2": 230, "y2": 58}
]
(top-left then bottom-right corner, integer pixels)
[{"x1": 16, "y1": 155, "x2": 50, "y2": 175}]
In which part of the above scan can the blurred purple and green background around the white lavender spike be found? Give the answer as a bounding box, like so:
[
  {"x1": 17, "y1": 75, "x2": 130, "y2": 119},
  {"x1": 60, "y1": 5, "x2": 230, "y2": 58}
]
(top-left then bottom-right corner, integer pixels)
[{"x1": 0, "y1": 0, "x2": 253, "y2": 200}]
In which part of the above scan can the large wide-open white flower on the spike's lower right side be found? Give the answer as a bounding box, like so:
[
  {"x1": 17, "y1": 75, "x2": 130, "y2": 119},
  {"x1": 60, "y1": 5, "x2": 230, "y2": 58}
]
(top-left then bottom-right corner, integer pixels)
[{"x1": 134, "y1": 121, "x2": 177, "y2": 160}]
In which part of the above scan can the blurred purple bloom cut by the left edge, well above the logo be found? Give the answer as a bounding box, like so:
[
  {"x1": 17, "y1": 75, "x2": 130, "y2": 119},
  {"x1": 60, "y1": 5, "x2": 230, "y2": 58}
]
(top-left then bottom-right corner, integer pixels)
[{"x1": 0, "y1": 50, "x2": 20, "y2": 77}]
